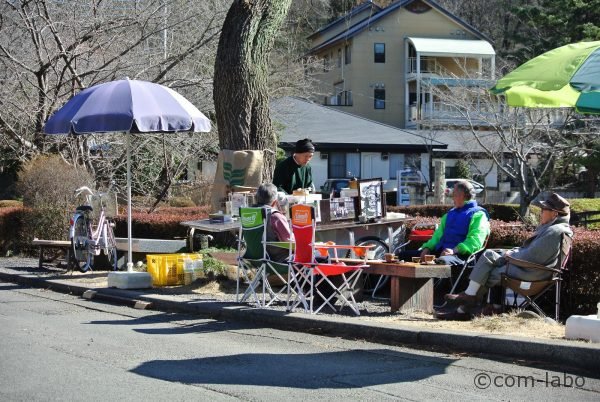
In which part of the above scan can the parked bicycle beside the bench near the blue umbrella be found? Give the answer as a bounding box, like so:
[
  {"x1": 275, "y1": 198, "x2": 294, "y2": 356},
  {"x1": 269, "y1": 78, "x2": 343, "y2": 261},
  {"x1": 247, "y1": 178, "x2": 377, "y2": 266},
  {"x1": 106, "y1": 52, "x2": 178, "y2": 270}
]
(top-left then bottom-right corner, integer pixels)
[{"x1": 69, "y1": 186, "x2": 118, "y2": 272}]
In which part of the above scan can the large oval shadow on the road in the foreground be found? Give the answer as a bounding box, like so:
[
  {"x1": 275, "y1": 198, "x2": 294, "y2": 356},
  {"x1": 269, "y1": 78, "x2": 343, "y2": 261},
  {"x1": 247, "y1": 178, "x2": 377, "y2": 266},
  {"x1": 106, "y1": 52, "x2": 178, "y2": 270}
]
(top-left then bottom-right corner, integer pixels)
[{"x1": 131, "y1": 349, "x2": 456, "y2": 389}]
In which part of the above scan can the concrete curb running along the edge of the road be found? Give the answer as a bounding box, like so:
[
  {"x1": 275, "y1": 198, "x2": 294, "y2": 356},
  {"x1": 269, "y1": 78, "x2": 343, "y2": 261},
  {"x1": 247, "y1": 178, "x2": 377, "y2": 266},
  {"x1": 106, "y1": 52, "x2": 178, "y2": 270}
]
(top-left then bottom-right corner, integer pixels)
[{"x1": 0, "y1": 272, "x2": 600, "y2": 370}]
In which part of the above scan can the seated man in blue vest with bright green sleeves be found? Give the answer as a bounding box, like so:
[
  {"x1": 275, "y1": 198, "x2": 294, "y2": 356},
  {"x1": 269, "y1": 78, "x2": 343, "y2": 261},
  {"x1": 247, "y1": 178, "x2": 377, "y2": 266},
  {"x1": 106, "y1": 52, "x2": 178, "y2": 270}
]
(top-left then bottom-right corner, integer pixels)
[{"x1": 408, "y1": 180, "x2": 490, "y2": 265}]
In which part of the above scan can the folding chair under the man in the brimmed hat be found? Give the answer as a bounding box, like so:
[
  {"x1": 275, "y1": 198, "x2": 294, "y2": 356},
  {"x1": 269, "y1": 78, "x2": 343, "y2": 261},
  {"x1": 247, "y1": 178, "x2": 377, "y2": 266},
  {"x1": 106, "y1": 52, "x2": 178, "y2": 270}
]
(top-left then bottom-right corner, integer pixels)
[{"x1": 500, "y1": 234, "x2": 573, "y2": 321}]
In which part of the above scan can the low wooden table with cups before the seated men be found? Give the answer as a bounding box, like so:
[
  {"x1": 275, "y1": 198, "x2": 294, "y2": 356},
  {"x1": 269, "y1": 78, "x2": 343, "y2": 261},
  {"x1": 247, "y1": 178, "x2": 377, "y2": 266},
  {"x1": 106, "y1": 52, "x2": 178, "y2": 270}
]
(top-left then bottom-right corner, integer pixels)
[{"x1": 337, "y1": 258, "x2": 451, "y2": 313}]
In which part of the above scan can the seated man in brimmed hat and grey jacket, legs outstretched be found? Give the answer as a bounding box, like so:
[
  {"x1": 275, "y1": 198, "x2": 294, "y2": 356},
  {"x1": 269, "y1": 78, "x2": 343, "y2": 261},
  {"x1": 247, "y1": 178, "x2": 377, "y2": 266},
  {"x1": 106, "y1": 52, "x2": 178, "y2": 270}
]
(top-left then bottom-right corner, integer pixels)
[{"x1": 436, "y1": 193, "x2": 573, "y2": 320}]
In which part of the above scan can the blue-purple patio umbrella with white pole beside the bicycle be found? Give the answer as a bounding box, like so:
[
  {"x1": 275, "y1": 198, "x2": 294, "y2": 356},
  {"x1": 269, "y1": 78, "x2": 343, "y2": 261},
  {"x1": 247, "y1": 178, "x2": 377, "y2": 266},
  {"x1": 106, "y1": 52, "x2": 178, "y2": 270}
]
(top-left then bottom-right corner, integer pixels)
[{"x1": 44, "y1": 79, "x2": 211, "y2": 267}]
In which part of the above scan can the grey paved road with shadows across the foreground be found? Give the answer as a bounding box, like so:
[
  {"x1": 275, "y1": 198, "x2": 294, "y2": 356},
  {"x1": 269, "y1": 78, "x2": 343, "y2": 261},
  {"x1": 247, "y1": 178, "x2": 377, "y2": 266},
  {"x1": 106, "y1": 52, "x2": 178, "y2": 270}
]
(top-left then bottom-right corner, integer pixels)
[{"x1": 0, "y1": 283, "x2": 600, "y2": 401}]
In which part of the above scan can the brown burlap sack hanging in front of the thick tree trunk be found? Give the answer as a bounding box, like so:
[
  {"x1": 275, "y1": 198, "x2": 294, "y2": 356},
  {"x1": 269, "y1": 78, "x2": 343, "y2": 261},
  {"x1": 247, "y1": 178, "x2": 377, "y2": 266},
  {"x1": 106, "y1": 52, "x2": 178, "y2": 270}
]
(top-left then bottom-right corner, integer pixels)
[{"x1": 211, "y1": 149, "x2": 264, "y2": 212}]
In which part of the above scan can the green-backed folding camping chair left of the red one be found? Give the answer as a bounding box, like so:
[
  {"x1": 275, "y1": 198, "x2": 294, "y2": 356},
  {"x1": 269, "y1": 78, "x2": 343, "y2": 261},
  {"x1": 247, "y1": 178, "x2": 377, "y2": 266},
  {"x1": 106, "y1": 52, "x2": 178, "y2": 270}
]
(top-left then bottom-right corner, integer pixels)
[{"x1": 236, "y1": 207, "x2": 293, "y2": 307}]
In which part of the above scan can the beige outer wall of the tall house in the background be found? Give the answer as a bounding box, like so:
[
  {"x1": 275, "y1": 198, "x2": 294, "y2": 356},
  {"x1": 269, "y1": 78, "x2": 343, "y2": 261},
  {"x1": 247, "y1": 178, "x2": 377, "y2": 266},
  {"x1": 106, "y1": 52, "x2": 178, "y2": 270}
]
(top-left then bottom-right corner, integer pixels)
[{"x1": 316, "y1": 8, "x2": 477, "y2": 127}]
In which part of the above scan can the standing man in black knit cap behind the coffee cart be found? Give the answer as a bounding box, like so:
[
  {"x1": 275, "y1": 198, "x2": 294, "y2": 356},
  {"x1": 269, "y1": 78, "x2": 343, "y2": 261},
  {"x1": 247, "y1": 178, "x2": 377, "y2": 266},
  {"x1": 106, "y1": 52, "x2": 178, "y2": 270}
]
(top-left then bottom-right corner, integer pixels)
[{"x1": 273, "y1": 138, "x2": 315, "y2": 194}]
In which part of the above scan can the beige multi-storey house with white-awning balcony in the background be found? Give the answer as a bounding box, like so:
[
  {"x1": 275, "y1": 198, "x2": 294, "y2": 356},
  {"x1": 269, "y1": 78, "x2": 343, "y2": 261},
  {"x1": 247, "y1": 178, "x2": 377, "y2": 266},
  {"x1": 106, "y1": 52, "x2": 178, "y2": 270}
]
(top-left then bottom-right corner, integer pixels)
[{"x1": 309, "y1": 0, "x2": 495, "y2": 128}]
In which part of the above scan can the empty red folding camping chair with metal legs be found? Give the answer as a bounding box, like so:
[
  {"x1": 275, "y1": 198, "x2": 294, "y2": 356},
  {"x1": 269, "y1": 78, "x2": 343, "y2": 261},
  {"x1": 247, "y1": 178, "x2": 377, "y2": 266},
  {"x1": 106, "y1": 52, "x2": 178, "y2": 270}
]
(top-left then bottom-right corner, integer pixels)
[{"x1": 287, "y1": 204, "x2": 373, "y2": 315}]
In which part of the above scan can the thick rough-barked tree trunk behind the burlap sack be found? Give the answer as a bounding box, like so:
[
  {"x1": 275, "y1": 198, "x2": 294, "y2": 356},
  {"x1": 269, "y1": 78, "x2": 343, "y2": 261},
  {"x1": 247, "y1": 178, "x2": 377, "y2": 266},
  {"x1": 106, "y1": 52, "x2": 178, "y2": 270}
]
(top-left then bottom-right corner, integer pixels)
[{"x1": 213, "y1": 0, "x2": 291, "y2": 181}]
